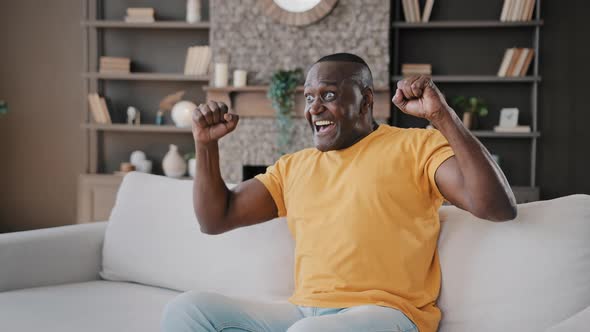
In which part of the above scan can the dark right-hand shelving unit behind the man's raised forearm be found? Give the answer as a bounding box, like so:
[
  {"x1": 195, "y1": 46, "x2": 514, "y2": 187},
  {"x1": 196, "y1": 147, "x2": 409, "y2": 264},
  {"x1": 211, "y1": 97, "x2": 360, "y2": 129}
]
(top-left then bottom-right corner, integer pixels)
[{"x1": 391, "y1": 0, "x2": 543, "y2": 202}]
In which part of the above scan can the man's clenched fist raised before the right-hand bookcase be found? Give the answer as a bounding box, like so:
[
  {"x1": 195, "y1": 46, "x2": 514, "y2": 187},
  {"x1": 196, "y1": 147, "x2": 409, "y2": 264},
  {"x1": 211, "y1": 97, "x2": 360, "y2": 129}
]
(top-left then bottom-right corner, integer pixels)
[{"x1": 392, "y1": 75, "x2": 451, "y2": 123}]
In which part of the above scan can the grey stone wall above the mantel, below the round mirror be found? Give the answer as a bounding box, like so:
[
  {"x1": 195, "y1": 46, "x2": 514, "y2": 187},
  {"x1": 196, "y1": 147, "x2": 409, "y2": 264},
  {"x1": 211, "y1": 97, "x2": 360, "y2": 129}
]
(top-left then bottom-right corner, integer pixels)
[{"x1": 210, "y1": 0, "x2": 390, "y2": 86}]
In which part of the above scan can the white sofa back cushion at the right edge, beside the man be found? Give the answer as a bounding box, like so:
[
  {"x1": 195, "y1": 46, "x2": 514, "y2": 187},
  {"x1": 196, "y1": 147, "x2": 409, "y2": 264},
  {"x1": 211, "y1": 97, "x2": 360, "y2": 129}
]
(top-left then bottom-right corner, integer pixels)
[{"x1": 438, "y1": 195, "x2": 590, "y2": 332}]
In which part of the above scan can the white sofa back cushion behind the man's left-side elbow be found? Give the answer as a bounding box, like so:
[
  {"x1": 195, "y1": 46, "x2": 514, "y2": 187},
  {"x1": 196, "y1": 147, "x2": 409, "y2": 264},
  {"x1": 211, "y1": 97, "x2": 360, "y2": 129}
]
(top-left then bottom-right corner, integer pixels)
[{"x1": 101, "y1": 173, "x2": 294, "y2": 300}]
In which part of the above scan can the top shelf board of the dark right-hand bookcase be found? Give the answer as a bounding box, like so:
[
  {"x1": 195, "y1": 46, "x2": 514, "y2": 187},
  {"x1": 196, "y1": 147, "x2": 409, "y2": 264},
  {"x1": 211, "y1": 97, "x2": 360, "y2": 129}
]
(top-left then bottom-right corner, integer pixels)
[{"x1": 392, "y1": 20, "x2": 543, "y2": 29}]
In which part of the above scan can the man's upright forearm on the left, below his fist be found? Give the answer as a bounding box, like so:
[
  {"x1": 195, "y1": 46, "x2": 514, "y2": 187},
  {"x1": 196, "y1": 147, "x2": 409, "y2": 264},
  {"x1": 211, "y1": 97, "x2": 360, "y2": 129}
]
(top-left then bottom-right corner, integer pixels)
[{"x1": 193, "y1": 141, "x2": 230, "y2": 233}]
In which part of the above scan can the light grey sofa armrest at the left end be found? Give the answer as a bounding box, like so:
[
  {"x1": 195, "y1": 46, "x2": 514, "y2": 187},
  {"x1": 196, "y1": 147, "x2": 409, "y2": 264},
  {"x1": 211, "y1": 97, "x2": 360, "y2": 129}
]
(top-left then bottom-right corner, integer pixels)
[{"x1": 0, "y1": 222, "x2": 106, "y2": 292}]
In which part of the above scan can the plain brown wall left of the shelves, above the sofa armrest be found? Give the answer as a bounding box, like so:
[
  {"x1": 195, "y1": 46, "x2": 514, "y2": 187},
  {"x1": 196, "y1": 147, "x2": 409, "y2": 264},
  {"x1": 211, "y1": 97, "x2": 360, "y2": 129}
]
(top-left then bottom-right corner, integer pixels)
[{"x1": 0, "y1": 0, "x2": 83, "y2": 232}]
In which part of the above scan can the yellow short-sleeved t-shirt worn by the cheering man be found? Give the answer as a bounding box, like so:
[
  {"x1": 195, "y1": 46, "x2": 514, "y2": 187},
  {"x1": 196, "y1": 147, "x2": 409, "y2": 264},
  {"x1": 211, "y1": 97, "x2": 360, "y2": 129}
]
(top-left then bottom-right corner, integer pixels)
[{"x1": 256, "y1": 125, "x2": 453, "y2": 332}]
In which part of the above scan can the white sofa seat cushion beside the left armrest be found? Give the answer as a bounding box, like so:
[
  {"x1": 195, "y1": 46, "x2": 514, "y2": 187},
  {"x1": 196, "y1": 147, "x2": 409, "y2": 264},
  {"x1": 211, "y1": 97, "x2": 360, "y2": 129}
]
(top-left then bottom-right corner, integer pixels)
[{"x1": 0, "y1": 281, "x2": 178, "y2": 332}]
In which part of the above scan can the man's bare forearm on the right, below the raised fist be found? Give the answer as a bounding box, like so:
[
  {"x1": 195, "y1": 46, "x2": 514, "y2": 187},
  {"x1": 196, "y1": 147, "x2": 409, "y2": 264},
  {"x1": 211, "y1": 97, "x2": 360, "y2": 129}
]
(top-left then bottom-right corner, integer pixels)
[{"x1": 433, "y1": 109, "x2": 516, "y2": 220}]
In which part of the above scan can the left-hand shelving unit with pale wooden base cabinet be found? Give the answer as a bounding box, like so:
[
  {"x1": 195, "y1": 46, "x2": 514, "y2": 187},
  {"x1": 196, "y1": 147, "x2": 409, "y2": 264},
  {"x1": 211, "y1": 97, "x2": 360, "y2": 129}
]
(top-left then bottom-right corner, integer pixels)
[{"x1": 78, "y1": 0, "x2": 209, "y2": 222}]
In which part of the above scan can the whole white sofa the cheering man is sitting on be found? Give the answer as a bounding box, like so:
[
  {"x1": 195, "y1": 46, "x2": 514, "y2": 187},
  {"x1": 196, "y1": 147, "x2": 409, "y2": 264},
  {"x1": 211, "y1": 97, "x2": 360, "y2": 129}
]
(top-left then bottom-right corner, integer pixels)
[{"x1": 0, "y1": 173, "x2": 590, "y2": 332}]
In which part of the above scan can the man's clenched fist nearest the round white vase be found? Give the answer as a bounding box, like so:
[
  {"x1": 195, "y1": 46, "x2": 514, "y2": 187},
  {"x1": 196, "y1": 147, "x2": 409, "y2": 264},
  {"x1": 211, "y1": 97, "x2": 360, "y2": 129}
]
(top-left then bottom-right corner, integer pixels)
[{"x1": 193, "y1": 101, "x2": 240, "y2": 144}]
